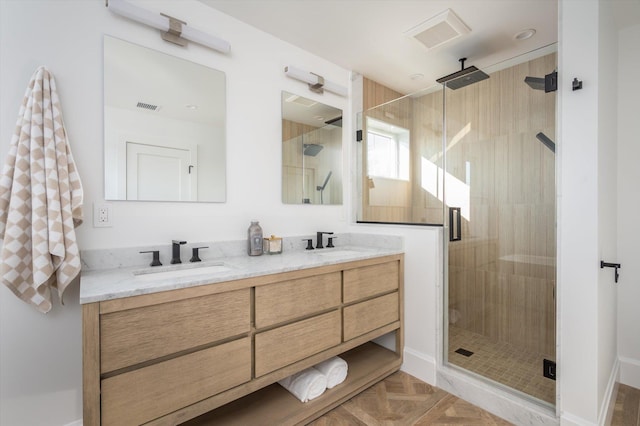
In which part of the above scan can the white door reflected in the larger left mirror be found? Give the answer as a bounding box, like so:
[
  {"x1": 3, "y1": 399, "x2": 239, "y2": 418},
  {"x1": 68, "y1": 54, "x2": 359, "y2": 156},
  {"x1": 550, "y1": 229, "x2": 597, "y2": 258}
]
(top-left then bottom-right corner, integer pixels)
[{"x1": 127, "y1": 142, "x2": 197, "y2": 201}]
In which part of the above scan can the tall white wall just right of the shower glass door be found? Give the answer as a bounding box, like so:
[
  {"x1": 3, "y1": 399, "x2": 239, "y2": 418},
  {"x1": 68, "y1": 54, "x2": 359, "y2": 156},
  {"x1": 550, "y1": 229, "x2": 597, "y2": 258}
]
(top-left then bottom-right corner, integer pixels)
[{"x1": 558, "y1": 0, "x2": 617, "y2": 424}]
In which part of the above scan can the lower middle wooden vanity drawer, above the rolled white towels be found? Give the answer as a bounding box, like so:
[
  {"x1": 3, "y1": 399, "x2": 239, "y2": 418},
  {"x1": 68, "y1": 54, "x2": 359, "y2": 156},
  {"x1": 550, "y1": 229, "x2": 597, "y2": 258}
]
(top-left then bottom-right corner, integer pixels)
[{"x1": 255, "y1": 310, "x2": 342, "y2": 377}]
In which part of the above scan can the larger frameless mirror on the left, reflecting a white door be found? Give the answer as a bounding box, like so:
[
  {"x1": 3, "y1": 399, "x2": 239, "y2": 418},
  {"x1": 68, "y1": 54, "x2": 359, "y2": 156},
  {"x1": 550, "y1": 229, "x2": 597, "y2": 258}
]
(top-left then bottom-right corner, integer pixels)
[{"x1": 104, "y1": 36, "x2": 226, "y2": 202}]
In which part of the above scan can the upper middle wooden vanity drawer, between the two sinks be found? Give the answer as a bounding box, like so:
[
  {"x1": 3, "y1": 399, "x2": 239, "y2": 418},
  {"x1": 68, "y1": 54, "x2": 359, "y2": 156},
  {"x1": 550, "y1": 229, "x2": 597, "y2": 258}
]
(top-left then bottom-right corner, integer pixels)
[{"x1": 255, "y1": 272, "x2": 342, "y2": 328}]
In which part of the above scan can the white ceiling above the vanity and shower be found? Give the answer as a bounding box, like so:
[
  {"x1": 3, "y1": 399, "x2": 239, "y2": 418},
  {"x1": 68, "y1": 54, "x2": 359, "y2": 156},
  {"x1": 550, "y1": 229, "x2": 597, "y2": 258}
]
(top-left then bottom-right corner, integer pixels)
[{"x1": 200, "y1": 0, "x2": 560, "y2": 93}]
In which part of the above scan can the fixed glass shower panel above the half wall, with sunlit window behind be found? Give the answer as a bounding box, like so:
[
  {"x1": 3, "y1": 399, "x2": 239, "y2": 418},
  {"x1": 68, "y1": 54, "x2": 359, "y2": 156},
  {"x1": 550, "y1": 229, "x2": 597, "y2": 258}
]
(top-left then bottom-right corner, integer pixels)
[{"x1": 356, "y1": 82, "x2": 443, "y2": 226}]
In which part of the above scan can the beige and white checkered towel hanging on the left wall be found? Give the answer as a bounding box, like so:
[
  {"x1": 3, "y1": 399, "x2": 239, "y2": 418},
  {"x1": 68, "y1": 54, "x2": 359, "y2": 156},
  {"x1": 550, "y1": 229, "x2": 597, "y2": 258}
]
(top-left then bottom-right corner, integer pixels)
[{"x1": 0, "y1": 67, "x2": 82, "y2": 312}]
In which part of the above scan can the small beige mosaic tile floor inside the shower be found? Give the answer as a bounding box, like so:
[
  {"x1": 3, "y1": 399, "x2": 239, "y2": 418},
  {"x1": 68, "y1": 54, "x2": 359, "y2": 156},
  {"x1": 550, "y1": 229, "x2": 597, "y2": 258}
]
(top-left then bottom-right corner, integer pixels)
[{"x1": 449, "y1": 325, "x2": 556, "y2": 404}]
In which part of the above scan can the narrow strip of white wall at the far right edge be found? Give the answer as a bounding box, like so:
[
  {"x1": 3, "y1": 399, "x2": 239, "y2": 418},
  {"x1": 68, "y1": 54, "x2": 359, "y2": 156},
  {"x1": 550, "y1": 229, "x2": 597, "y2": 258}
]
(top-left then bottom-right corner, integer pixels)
[{"x1": 617, "y1": 23, "x2": 640, "y2": 388}]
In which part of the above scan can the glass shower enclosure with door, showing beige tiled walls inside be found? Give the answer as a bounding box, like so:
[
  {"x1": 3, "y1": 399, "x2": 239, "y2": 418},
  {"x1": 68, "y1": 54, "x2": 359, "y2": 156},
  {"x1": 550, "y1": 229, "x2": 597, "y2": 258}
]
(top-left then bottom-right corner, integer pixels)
[{"x1": 357, "y1": 48, "x2": 557, "y2": 406}]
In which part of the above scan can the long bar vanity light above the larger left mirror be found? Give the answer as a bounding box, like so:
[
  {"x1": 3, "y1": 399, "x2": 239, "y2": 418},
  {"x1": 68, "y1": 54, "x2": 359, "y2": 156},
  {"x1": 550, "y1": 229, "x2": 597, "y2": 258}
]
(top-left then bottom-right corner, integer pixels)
[{"x1": 106, "y1": 0, "x2": 231, "y2": 53}]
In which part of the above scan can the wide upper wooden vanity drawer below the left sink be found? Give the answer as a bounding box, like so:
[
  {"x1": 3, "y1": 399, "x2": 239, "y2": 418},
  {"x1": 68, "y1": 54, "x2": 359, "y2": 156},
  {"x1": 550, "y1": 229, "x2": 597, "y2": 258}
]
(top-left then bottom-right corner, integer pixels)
[{"x1": 100, "y1": 289, "x2": 251, "y2": 373}]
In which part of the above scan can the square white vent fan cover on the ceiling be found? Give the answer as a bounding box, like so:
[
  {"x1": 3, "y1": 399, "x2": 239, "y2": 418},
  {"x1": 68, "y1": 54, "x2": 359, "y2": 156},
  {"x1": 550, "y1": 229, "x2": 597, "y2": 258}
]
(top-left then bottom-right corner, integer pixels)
[{"x1": 404, "y1": 9, "x2": 471, "y2": 49}]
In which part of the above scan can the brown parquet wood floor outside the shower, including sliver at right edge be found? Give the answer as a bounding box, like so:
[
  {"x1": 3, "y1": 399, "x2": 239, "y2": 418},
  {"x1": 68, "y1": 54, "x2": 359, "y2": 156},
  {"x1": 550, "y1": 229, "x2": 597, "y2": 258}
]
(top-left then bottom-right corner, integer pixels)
[{"x1": 310, "y1": 371, "x2": 640, "y2": 426}]
